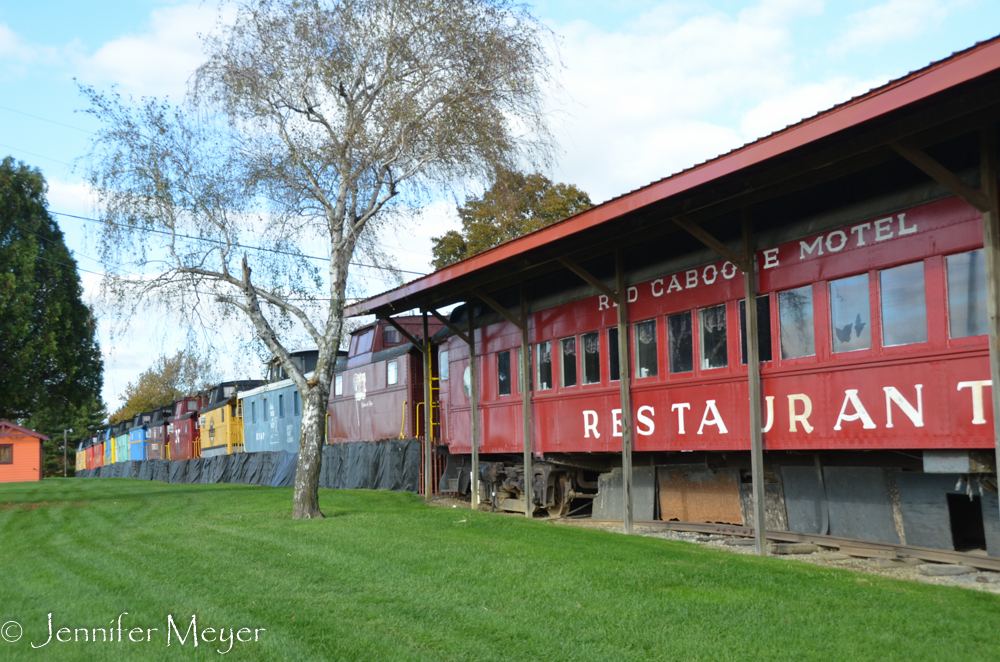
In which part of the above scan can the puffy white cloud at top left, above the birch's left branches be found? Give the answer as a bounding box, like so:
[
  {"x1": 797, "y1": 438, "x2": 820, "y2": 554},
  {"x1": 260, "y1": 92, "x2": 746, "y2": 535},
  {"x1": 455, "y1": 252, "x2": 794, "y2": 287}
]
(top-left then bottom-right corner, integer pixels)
[{"x1": 77, "y1": 3, "x2": 226, "y2": 100}]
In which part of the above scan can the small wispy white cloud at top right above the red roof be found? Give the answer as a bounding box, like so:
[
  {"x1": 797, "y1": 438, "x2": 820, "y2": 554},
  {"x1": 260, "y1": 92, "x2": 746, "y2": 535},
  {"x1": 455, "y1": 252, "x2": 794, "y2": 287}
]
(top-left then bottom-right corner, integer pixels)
[{"x1": 830, "y1": 0, "x2": 959, "y2": 55}]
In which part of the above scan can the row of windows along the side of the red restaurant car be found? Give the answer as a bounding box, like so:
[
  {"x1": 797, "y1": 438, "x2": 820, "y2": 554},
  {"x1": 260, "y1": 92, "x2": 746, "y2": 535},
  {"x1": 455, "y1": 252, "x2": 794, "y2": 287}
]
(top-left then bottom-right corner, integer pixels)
[{"x1": 488, "y1": 249, "x2": 987, "y2": 396}]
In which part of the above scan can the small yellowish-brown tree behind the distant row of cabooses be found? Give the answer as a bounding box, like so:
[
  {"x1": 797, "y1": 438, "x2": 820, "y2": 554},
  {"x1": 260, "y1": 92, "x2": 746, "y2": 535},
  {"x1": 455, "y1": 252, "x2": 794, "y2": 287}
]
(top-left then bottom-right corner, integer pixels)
[{"x1": 111, "y1": 349, "x2": 221, "y2": 425}]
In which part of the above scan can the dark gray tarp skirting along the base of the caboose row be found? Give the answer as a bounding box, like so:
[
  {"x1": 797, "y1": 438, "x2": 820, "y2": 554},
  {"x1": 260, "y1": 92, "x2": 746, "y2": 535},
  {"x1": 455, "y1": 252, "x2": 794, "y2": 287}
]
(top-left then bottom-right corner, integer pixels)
[{"x1": 76, "y1": 439, "x2": 420, "y2": 492}]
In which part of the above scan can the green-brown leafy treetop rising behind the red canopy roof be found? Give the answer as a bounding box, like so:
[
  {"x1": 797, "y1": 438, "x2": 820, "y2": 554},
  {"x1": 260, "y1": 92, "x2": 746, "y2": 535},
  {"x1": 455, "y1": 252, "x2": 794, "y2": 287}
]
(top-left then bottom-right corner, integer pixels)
[{"x1": 431, "y1": 170, "x2": 591, "y2": 269}]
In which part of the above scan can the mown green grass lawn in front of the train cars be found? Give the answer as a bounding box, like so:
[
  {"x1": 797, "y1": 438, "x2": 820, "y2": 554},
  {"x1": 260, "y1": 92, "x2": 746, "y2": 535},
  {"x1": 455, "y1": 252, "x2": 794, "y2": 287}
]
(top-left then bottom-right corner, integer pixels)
[{"x1": 0, "y1": 479, "x2": 1000, "y2": 662}]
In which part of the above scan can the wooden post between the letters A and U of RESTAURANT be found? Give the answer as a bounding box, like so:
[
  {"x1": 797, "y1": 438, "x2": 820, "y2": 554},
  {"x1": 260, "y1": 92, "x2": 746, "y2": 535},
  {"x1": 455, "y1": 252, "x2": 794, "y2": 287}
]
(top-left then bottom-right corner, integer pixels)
[{"x1": 743, "y1": 215, "x2": 767, "y2": 556}]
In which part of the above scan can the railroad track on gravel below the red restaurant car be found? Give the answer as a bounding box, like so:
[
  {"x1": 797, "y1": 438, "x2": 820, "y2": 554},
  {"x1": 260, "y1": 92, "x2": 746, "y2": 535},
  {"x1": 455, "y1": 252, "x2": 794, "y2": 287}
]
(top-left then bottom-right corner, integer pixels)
[{"x1": 590, "y1": 519, "x2": 1000, "y2": 572}]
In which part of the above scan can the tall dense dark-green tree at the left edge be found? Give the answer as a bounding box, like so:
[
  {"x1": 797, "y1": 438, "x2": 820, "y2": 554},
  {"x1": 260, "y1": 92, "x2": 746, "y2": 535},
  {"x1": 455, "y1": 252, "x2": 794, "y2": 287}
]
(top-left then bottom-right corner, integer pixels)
[{"x1": 0, "y1": 157, "x2": 104, "y2": 420}]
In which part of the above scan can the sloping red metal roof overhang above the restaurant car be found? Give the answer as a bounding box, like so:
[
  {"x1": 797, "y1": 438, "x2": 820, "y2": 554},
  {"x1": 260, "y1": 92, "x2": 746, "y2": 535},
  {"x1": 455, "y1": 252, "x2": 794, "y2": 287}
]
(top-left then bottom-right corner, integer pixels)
[{"x1": 345, "y1": 37, "x2": 1000, "y2": 318}]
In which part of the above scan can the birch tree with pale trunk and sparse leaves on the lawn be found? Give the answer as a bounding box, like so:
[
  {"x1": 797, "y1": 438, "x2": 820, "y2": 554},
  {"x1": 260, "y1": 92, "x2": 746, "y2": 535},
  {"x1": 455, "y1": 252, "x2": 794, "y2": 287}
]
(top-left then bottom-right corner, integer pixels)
[{"x1": 84, "y1": 0, "x2": 551, "y2": 518}]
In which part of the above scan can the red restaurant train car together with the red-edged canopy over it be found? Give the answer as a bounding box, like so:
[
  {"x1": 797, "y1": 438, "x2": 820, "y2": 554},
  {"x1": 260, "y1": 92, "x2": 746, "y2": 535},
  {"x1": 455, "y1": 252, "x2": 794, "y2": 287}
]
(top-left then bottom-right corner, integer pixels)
[{"x1": 346, "y1": 39, "x2": 1000, "y2": 555}]
